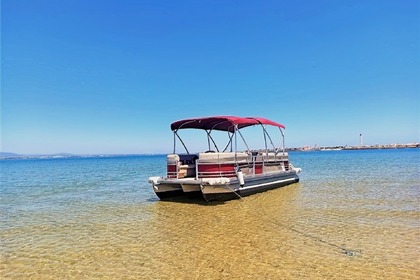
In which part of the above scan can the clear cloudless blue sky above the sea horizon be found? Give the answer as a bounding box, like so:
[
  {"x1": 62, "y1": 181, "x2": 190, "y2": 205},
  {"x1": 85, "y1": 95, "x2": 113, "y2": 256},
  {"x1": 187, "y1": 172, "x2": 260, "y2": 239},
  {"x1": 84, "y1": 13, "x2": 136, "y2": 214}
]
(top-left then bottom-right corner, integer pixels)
[{"x1": 1, "y1": 0, "x2": 420, "y2": 154}]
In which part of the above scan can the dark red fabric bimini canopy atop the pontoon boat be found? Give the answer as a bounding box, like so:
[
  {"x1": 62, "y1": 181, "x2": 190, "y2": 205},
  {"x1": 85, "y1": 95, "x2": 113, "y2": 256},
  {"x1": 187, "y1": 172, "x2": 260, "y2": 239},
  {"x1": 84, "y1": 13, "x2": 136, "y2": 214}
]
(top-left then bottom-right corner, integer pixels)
[{"x1": 171, "y1": 116, "x2": 285, "y2": 132}]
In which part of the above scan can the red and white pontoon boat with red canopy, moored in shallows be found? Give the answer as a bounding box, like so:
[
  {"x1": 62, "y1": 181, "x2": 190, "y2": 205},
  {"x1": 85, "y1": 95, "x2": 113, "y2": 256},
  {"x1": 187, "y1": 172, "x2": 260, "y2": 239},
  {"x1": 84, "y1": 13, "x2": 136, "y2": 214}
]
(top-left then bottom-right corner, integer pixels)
[{"x1": 149, "y1": 116, "x2": 301, "y2": 202}]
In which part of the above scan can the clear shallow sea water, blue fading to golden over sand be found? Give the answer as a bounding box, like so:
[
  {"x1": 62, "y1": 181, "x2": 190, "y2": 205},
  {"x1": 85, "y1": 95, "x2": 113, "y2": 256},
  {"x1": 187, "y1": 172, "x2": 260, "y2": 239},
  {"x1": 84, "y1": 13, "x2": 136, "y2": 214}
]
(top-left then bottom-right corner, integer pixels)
[{"x1": 0, "y1": 149, "x2": 420, "y2": 279}]
